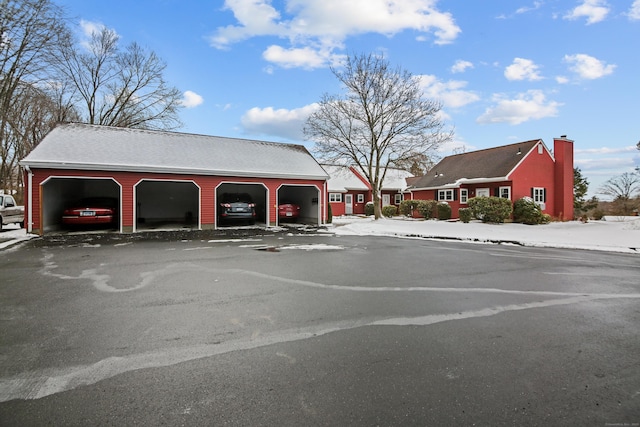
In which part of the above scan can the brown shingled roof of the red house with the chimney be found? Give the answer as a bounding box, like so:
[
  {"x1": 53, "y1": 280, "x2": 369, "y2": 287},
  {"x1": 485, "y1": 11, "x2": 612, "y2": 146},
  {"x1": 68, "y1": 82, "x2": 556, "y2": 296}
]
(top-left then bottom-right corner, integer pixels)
[{"x1": 412, "y1": 139, "x2": 544, "y2": 189}]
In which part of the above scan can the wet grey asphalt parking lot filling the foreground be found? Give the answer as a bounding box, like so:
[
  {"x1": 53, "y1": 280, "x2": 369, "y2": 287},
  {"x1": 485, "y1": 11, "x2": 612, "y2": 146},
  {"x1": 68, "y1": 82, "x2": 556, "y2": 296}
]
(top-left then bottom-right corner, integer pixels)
[{"x1": 0, "y1": 233, "x2": 640, "y2": 425}]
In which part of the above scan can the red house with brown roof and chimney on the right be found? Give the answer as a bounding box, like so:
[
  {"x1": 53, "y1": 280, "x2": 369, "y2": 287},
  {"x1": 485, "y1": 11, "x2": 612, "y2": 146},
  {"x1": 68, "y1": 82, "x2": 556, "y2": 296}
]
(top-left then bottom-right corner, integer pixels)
[{"x1": 409, "y1": 135, "x2": 573, "y2": 220}]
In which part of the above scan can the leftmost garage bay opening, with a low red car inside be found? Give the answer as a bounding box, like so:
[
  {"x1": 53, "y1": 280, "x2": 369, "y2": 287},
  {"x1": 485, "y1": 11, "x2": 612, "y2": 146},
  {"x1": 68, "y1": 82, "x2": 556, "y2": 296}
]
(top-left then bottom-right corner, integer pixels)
[{"x1": 41, "y1": 177, "x2": 122, "y2": 233}]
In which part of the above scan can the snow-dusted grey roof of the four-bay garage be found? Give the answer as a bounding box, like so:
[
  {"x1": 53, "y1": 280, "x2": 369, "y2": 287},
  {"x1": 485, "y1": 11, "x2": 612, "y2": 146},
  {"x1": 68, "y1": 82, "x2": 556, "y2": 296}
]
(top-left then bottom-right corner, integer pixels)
[{"x1": 21, "y1": 123, "x2": 328, "y2": 180}]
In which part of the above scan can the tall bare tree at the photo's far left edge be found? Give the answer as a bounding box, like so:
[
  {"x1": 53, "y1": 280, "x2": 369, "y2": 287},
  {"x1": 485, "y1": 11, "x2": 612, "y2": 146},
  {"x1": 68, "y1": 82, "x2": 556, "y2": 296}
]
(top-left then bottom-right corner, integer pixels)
[{"x1": 0, "y1": 0, "x2": 67, "y2": 199}]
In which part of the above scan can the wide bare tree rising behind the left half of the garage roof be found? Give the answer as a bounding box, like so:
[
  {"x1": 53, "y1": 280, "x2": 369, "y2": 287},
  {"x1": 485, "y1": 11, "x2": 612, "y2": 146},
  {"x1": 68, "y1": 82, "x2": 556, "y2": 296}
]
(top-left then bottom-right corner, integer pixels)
[{"x1": 58, "y1": 27, "x2": 182, "y2": 130}]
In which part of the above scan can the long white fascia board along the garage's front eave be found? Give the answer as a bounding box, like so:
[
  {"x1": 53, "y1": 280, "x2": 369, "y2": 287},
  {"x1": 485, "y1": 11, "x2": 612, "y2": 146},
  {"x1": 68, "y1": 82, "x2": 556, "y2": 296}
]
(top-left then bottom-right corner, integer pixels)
[{"x1": 20, "y1": 161, "x2": 329, "y2": 181}]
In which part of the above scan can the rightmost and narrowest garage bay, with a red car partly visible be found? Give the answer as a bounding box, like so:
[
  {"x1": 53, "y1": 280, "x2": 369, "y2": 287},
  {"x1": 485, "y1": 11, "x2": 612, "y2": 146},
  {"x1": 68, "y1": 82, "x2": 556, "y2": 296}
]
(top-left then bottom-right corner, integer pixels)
[{"x1": 278, "y1": 185, "x2": 320, "y2": 229}]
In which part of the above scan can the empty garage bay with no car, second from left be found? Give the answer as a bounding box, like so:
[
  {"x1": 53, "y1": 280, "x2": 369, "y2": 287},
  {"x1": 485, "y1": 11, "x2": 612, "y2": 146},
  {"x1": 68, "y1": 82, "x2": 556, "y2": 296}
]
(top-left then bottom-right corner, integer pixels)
[{"x1": 134, "y1": 180, "x2": 200, "y2": 230}]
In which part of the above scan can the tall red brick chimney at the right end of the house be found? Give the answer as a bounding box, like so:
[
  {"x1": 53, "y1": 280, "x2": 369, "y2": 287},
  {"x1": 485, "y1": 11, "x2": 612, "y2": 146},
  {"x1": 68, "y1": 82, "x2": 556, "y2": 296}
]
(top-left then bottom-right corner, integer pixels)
[{"x1": 553, "y1": 135, "x2": 573, "y2": 221}]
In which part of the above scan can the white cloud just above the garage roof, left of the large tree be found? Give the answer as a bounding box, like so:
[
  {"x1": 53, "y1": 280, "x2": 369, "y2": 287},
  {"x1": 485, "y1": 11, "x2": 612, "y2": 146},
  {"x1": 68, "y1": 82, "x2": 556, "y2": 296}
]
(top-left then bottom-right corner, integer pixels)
[{"x1": 241, "y1": 103, "x2": 318, "y2": 141}]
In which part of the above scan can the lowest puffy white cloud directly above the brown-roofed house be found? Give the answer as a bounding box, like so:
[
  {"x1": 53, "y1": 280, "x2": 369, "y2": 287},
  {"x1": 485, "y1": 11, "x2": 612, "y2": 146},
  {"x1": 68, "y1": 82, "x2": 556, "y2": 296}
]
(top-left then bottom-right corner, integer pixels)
[{"x1": 476, "y1": 90, "x2": 562, "y2": 125}]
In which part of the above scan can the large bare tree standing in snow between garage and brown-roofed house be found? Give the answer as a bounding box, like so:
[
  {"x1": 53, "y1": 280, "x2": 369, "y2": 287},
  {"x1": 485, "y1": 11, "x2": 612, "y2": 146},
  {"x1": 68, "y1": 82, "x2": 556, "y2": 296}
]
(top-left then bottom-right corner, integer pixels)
[{"x1": 304, "y1": 55, "x2": 453, "y2": 219}]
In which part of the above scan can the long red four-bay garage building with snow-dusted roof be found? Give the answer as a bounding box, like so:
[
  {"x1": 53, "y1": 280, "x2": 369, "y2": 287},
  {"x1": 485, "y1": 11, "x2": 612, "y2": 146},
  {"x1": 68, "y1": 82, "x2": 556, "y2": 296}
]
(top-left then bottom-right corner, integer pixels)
[{"x1": 21, "y1": 124, "x2": 328, "y2": 234}]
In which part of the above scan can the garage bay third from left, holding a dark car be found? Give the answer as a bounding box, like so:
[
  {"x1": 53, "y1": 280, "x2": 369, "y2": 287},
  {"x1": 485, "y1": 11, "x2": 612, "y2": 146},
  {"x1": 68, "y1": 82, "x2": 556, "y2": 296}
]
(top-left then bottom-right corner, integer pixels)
[{"x1": 215, "y1": 183, "x2": 269, "y2": 227}]
